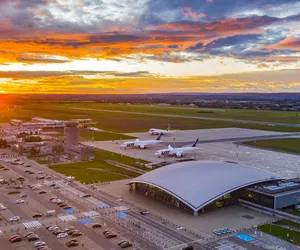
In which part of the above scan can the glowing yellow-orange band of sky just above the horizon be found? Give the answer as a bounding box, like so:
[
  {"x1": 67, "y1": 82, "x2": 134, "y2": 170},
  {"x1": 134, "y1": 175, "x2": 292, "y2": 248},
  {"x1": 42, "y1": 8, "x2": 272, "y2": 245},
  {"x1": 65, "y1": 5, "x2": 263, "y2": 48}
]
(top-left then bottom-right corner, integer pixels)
[{"x1": 0, "y1": 70, "x2": 300, "y2": 94}]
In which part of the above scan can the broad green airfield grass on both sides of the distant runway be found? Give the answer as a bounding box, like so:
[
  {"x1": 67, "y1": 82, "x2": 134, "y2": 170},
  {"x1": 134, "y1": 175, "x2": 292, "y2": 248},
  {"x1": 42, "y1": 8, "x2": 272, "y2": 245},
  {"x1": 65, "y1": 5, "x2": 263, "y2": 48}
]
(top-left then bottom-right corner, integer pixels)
[{"x1": 0, "y1": 103, "x2": 300, "y2": 134}]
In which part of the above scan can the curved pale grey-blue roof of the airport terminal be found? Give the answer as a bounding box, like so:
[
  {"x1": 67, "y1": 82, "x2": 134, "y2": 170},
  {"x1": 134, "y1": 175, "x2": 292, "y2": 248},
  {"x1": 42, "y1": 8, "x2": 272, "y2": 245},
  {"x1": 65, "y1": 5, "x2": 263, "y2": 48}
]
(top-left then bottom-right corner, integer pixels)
[{"x1": 128, "y1": 161, "x2": 282, "y2": 211}]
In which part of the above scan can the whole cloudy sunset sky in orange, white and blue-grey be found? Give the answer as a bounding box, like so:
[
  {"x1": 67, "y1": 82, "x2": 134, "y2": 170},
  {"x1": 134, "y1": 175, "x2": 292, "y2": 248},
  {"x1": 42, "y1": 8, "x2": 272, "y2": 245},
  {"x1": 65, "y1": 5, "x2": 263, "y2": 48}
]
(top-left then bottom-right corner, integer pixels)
[{"x1": 0, "y1": 0, "x2": 300, "y2": 94}]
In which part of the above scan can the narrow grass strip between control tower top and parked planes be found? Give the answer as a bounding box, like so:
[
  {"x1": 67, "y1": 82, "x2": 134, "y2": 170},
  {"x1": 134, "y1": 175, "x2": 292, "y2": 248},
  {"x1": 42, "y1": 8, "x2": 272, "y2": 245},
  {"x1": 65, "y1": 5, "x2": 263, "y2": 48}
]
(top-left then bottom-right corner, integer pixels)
[{"x1": 79, "y1": 131, "x2": 135, "y2": 141}]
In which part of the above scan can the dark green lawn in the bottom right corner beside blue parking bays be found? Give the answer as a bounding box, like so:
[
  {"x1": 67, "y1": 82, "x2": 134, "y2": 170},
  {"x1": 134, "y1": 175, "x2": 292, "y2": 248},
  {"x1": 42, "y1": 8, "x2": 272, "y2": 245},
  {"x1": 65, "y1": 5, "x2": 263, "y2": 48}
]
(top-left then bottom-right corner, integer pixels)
[{"x1": 258, "y1": 224, "x2": 300, "y2": 246}]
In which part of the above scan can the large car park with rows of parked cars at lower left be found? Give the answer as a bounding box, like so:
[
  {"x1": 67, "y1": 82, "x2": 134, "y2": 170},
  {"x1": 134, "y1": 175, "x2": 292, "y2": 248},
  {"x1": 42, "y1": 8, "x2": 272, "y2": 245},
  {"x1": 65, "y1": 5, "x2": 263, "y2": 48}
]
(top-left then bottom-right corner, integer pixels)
[{"x1": 0, "y1": 158, "x2": 146, "y2": 250}]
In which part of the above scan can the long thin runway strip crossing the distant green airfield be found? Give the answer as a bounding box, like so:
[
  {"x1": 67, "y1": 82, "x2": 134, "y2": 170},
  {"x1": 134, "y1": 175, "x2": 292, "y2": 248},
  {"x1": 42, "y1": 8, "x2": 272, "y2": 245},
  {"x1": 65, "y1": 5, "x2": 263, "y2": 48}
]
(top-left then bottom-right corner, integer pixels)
[{"x1": 72, "y1": 108, "x2": 300, "y2": 128}]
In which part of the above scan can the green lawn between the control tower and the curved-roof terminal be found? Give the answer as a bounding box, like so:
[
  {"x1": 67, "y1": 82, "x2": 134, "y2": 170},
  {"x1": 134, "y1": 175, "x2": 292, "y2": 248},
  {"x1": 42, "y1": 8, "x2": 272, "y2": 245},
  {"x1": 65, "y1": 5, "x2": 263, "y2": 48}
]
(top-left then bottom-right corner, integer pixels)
[{"x1": 50, "y1": 150, "x2": 147, "y2": 184}]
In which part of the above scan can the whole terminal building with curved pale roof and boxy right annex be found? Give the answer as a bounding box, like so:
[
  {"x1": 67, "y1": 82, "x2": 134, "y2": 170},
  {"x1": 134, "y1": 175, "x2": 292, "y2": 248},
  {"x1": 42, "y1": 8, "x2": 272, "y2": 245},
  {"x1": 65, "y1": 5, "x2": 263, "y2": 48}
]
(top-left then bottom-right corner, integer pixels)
[{"x1": 127, "y1": 161, "x2": 300, "y2": 216}]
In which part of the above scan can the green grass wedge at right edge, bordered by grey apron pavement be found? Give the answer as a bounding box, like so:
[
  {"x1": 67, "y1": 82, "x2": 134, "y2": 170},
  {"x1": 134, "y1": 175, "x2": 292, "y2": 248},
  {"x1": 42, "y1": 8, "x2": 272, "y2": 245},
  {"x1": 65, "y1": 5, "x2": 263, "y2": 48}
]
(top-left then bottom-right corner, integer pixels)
[{"x1": 244, "y1": 138, "x2": 300, "y2": 154}]
